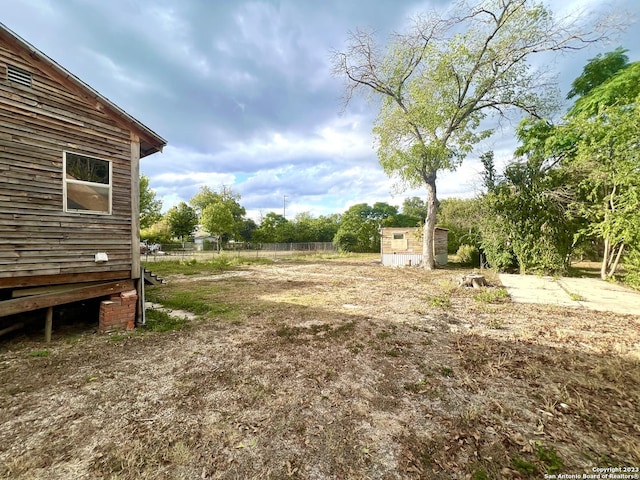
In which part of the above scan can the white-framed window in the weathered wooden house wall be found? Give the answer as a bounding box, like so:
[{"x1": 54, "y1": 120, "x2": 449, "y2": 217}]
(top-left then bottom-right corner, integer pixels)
[{"x1": 62, "y1": 152, "x2": 112, "y2": 215}]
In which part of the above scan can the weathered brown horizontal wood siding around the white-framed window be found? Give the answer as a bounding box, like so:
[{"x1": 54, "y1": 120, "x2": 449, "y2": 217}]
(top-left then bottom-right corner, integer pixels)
[{"x1": 0, "y1": 39, "x2": 139, "y2": 287}]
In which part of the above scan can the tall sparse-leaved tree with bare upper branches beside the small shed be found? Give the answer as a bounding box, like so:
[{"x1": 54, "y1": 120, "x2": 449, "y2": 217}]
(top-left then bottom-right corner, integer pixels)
[{"x1": 333, "y1": 0, "x2": 612, "y2": 269}]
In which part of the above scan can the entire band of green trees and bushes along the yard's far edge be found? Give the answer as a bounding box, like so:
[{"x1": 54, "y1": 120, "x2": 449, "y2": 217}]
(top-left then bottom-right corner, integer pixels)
[{"x1": 140, "y1": 48, "x2": 640, "y2": 285}]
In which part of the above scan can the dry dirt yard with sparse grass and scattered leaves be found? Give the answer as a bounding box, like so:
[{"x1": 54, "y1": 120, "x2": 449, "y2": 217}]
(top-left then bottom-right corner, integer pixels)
[{"x1": 0, "y1": 257, "x2": 640, "y2": 480}]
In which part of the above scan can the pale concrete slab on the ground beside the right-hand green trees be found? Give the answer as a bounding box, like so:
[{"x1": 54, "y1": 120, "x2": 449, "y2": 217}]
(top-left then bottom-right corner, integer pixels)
[{"x1": 498, "y1": 274, "x2": 640, "y2": 315}]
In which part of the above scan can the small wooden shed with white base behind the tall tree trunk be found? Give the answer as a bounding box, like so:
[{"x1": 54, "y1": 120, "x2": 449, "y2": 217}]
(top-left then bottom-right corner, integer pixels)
[{"x1": 380, "y1": 227, "x2": 449, "y2": 266}]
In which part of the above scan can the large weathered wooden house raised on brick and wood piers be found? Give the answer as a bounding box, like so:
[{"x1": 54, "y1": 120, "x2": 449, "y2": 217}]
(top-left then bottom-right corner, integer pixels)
[{"x1": 0, "y1": 23, "x2": 166, "y2": 333}]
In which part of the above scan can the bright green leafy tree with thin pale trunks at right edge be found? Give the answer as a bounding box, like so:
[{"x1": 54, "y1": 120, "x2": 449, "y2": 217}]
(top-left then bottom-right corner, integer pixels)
[{"x1": 557, "y1": 60, "x2": 640, "y2": 279}]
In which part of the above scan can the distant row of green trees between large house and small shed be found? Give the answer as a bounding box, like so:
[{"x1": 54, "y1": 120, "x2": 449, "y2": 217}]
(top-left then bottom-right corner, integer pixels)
[{"x1": 140, "y1": 183, "x2": 426, "y2": 253}]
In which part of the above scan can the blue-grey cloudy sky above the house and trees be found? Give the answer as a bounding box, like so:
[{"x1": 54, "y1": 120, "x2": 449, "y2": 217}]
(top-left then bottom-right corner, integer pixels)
[{"x1": 0, "y1": 0, "x2": 640, "y2": 220}]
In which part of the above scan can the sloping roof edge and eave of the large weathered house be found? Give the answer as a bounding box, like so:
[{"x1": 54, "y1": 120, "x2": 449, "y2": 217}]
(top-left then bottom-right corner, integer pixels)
[{"x1": 0, "y1": 22, "x2": 167, "y2": 157}]
